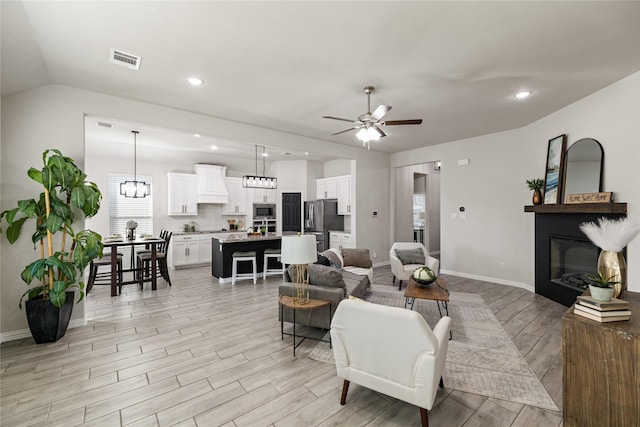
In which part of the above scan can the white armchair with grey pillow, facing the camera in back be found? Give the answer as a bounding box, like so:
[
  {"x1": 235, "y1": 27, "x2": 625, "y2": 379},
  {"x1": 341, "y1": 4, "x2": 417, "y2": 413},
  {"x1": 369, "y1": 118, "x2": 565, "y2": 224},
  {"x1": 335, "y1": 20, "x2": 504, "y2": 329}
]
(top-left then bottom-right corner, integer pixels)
[{"x1": 389, "y1": 242, "x2": 440, "y2": 290}]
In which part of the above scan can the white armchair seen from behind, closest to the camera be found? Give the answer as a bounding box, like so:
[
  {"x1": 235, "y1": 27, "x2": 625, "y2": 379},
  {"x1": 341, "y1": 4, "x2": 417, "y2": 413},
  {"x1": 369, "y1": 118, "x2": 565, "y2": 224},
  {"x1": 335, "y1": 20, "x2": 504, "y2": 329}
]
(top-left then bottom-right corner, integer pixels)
[{"x1": 331, "y1": 299, "x2": 451, "y2": 427}]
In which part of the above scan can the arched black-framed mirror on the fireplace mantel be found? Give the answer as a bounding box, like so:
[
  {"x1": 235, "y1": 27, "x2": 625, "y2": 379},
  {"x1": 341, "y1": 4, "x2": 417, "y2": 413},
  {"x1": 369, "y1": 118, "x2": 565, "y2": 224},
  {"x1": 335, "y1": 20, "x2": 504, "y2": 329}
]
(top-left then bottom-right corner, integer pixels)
[{"x1": 564, "y1": 138, "x2": 604, "y2": 196}]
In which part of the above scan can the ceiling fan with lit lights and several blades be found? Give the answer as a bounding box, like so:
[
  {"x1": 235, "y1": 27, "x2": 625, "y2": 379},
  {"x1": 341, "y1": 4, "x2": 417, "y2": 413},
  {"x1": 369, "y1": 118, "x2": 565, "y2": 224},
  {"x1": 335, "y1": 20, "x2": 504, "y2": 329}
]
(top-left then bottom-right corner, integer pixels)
[{"x1": 322, "y1": 86, "x2": 422, "y2": 149}]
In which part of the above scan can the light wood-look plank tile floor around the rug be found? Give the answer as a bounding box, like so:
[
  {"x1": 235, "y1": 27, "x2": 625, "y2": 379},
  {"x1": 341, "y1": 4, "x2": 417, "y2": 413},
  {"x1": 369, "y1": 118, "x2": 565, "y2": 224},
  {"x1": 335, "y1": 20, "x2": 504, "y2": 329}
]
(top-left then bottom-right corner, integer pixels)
[{"x1": 0, "y1": 267, "x2": 566, "y2": 427}]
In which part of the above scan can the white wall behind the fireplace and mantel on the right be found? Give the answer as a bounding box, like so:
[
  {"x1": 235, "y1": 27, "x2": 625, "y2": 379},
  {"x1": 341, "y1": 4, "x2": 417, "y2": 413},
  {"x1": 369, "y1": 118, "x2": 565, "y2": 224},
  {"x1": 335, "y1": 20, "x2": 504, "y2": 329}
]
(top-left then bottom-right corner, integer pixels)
[{"x1": 391, "y1": 72, "x2": 640, "y2": 291}]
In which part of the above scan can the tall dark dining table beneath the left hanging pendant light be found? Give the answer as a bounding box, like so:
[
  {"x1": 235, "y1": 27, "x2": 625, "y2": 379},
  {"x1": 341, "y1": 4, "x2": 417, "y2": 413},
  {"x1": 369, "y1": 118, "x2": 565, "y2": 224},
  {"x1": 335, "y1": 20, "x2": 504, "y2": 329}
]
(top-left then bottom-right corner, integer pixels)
[{"x1": 102, "y1": 236, "x2": 165, "y2": 297}]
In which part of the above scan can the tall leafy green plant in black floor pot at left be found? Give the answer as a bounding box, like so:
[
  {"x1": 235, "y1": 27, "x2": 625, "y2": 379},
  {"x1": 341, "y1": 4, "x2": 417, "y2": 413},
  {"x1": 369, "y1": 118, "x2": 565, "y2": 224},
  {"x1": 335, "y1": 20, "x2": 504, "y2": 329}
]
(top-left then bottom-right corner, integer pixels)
[{"x1": 0, "y1": 150, "x2": 103, "y2": 344}]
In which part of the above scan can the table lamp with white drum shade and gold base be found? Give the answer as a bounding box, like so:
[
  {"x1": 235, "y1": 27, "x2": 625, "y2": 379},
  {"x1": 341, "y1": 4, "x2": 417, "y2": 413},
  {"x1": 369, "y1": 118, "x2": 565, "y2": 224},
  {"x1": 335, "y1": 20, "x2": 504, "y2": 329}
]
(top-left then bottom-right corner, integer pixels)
[{"x1": 280, "y1": 234, "x2": 318, "y2": 304}]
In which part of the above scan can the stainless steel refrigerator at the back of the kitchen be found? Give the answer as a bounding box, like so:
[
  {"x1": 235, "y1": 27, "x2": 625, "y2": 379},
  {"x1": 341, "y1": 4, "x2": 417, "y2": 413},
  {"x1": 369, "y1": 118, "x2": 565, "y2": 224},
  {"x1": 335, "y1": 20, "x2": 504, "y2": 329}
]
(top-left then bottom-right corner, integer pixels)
[{"x1": 304, "y1": 199, "x2": 344, "y2": 252}]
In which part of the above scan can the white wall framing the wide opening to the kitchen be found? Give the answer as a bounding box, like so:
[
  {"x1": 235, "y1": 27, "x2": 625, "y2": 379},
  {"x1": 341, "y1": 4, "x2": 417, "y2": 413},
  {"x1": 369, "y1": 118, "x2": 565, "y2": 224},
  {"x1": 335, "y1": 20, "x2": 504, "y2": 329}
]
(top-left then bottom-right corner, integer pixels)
[{"x1": 0, "y1": 85, "x2": 390, "y2": 340}]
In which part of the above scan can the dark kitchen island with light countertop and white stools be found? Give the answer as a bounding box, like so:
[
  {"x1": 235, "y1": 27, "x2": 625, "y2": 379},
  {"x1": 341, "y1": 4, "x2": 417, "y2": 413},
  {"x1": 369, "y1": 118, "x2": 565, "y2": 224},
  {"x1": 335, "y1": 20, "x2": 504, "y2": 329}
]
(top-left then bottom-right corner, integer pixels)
[{"x1": 211, "y1": 233, "x2": 282, "y2": 283}]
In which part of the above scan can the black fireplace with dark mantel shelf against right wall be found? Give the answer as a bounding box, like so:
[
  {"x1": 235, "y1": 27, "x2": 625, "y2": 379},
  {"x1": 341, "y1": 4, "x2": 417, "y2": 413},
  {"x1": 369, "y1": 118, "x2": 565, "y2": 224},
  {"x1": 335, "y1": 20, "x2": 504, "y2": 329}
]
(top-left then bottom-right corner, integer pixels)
[{"x1": 528, "y1": 204, "x2": 626, "y2": 307}]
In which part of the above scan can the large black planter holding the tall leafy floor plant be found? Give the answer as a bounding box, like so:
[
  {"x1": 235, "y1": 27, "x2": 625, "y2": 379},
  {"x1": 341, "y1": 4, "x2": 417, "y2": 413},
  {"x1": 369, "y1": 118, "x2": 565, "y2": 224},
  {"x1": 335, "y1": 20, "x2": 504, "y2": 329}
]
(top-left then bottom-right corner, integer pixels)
[{"x1": 25, "y1": 292, "x2": 74, "y2": 344}]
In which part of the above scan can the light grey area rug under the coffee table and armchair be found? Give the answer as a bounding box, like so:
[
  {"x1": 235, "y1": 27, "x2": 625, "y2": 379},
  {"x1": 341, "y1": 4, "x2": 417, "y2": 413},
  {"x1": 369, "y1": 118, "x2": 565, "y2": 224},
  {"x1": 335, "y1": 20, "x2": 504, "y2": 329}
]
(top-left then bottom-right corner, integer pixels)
[{"x1": 309, "y1": 286, "x2": 559, "y2": 411}]
